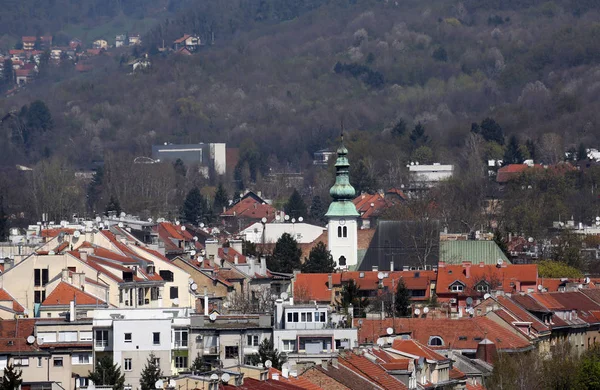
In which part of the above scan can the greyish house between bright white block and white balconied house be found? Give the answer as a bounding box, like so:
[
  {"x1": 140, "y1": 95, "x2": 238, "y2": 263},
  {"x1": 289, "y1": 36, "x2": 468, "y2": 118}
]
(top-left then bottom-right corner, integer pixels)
[{"x1": 190, "y1": 312, "x2": 272, "y2": 367}]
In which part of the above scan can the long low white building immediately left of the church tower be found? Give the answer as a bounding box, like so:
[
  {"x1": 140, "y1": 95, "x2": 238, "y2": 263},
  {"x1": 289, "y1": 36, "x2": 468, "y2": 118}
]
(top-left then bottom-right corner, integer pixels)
[{"x1": 240, "y1": 222, "x2": 325, "y2": 244}]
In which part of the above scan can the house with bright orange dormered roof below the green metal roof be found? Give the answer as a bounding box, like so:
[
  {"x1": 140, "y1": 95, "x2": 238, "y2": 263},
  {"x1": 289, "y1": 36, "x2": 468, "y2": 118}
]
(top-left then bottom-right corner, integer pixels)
[{"x1": 436, "y1": 261, "x2": 538, "y2": 317}]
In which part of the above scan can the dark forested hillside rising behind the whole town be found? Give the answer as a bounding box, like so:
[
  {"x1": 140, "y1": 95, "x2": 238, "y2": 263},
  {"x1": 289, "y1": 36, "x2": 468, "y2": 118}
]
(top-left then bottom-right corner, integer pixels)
[{"x1": 0, "y1": 0, "x2": 600, "y2": 225}]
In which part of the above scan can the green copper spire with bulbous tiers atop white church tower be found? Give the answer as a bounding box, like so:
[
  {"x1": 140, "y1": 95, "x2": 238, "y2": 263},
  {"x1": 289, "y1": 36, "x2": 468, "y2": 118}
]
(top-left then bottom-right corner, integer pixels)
[{"x1": 325, "y1": 133, "x2": 359, "y2": 217}]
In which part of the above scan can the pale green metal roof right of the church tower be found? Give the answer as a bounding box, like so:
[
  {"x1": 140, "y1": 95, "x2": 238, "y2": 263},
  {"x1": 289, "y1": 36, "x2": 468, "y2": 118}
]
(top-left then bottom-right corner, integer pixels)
[{"x1": 440, "y1": 240, "x2": 511, "y2": 265}]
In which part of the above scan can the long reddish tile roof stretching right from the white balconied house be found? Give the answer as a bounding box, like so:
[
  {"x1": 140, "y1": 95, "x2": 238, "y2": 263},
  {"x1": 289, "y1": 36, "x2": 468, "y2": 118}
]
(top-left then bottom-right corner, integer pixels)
[{"x1": 354, "y1": 317, "x2": 530, "y2": 351}]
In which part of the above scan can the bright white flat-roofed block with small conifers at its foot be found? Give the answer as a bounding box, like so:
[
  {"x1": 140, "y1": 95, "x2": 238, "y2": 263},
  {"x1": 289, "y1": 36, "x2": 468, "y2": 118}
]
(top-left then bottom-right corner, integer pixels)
[{"x1": 93, "y1": 308, "x2": 191, "y2": 388}]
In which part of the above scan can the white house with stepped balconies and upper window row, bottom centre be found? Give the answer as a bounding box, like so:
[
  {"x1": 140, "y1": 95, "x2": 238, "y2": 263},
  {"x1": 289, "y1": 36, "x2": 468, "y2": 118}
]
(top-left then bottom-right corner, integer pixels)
[{"x1": 273, "y1": 299, "x2": 358, "y2": 366}]
